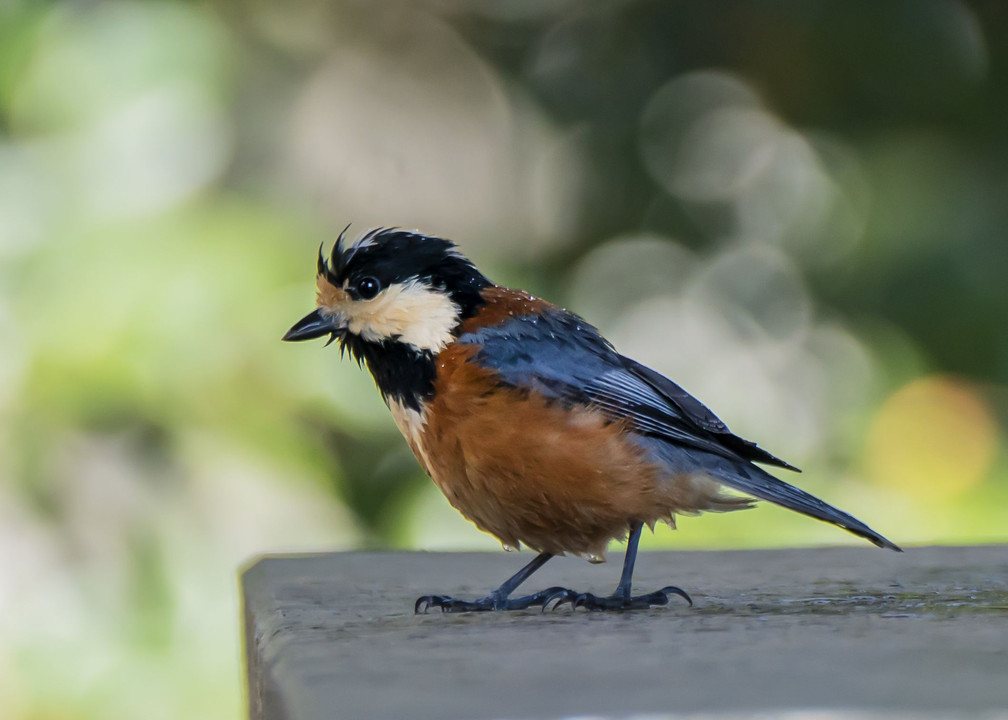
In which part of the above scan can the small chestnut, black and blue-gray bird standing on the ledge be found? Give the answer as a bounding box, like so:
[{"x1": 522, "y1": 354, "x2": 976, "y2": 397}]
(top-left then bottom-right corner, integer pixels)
[{"x1": 282, "y1": 226, "x2": 902, "y2": 613}]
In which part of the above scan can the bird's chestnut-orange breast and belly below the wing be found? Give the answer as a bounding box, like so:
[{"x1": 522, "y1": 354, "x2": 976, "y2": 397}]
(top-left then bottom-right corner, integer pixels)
[{"x1": 414, "y1": 344, "x2": 667, "y2": 559}]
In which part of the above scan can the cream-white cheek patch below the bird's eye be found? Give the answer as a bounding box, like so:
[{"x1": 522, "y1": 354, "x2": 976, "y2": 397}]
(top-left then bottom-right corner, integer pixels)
[{"x1": 340, "y1": 280, "x2": 461, "y2": 352}]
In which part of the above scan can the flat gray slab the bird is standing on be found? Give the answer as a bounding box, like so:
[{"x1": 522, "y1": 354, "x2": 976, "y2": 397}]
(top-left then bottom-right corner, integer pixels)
[{"x1": 242, "y1": 546, "x2": 1008, "y2": 720}]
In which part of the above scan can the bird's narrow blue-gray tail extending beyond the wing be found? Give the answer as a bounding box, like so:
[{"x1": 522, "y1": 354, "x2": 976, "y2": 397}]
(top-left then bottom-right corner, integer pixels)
[{"x1": 713, "y1": 463, "x2": 903, "y2": 553}]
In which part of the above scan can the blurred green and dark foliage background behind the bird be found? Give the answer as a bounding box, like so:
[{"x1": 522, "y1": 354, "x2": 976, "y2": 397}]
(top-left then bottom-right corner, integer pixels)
[{"x1": 0, "y1": 0, "x2": 1008, "y2": 720}]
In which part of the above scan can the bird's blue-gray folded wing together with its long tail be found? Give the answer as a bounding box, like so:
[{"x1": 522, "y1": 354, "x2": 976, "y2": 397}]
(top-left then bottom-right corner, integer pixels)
[{"x1": 457, "y1": 309, "x2": 899, "y2": 550}]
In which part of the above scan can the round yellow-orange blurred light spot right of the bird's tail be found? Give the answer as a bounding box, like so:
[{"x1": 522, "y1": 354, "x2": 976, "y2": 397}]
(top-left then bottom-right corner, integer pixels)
[{"x1": 866, "y1": 375, "x2": 998, "y2": 500}]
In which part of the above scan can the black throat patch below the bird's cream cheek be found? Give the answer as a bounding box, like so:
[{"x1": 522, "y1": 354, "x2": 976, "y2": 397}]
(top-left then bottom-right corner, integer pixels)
[{"x1": 340, "y1": 335, "x2": 437, "y2": 412}]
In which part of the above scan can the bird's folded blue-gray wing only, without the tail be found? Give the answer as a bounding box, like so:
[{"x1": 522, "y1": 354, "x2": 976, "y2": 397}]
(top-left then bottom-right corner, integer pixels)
[{"x1": 459, "y1": 309, "x2": 795, "y2": 470}]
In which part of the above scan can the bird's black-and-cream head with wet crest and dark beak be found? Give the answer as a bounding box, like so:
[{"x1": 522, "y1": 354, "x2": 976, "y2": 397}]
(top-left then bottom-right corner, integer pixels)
[{"x1": 283, "y1": 229, "x2": 491, "y2": 361}]
